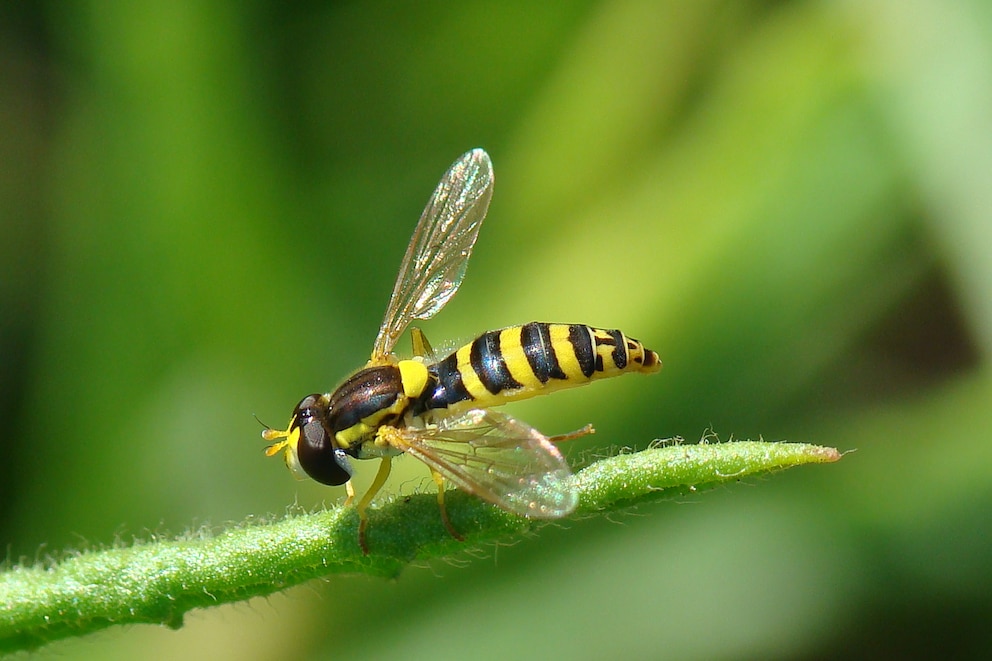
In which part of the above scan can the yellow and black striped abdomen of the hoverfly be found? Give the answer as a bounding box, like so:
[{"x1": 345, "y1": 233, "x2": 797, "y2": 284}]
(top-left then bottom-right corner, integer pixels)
[{"x1": 426, "y1": 322, "x2": 661, "y2": 409}]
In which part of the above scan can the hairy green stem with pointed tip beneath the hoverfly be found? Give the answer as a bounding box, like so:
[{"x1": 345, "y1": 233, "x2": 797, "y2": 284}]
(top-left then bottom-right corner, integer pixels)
[{"x1": 0, "y1": 441, "x2": 840, "y2": 652}]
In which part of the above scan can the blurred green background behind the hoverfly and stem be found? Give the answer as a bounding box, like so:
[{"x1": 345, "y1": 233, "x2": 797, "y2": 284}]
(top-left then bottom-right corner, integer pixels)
[{"x1": 0, "y1": 0, "x2": 992, "y2": 659}]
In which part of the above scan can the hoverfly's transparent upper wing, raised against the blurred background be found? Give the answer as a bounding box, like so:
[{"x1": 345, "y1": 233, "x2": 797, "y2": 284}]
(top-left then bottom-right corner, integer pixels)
[{"x1": 372, "y1": 149, "x2": 493, "y2": 362}]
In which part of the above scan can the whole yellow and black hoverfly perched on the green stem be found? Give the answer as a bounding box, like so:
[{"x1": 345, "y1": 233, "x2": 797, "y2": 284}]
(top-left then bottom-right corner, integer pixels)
[{"x1": 262, "y1": 149, "x2": 661, "y2": 554}]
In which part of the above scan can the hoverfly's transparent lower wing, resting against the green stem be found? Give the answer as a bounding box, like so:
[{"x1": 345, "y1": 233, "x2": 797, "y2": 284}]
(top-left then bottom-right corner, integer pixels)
[{"x1": 389, "y1": 409, "x2": 578, "y2": 519}]
